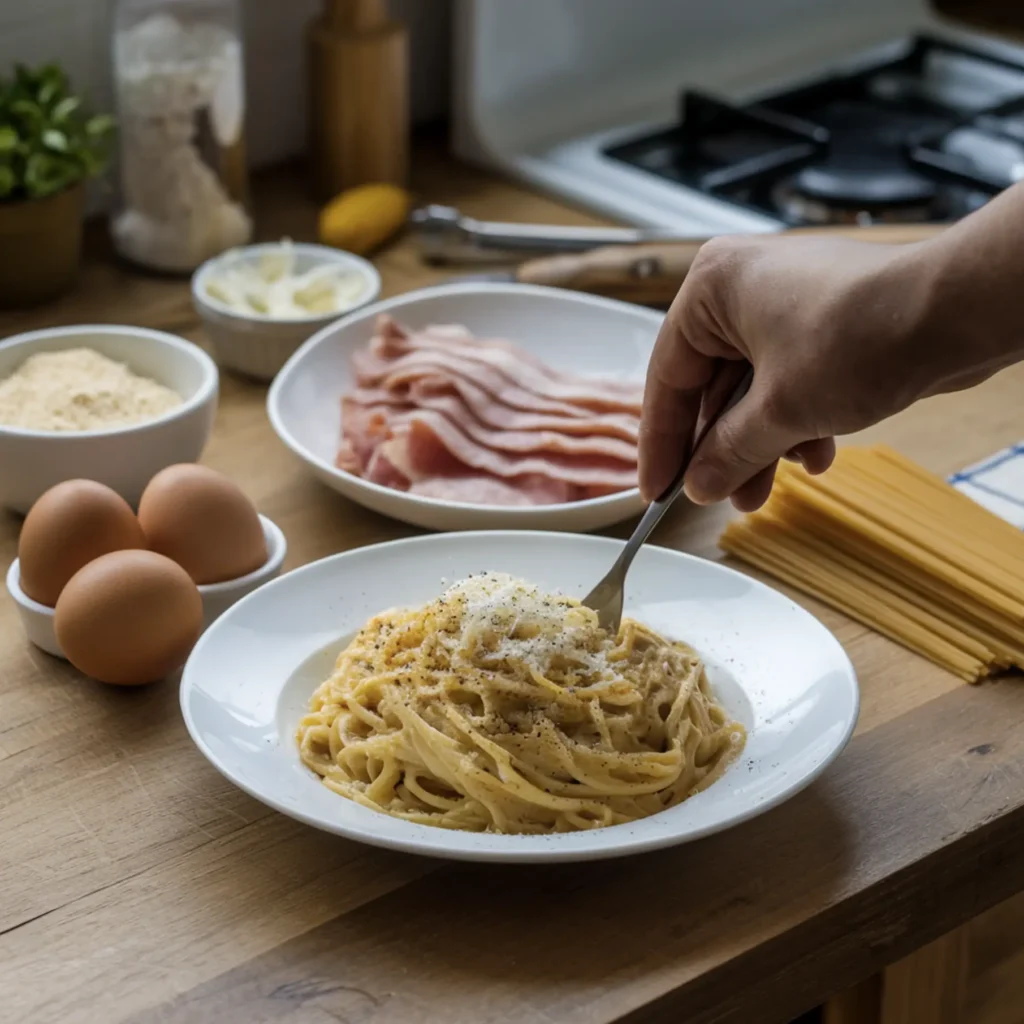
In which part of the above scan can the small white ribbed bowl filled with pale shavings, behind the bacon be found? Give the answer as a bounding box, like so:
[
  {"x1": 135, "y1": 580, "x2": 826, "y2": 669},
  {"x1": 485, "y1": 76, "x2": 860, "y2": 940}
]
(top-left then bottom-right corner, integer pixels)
[{"x1": 193, "y1": 240, "x2": 381, "y2": 381}]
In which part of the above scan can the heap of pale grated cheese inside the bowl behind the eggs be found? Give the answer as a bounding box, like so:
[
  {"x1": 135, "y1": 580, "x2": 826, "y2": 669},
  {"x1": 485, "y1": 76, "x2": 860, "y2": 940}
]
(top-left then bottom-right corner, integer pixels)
[{"x1": 0, "y1": 348, "x2": 182, "y2": 432}]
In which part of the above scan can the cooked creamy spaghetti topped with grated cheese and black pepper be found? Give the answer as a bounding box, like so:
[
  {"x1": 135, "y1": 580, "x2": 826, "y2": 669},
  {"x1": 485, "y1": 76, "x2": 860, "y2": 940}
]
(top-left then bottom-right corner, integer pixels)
[{"x1": 298, "y1": 573, "x2": 744, "y2": 834}]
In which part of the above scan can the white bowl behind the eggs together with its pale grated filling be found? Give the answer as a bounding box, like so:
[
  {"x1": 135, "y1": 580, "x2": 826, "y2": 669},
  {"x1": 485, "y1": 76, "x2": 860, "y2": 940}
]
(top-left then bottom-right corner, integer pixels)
[{"x1": 0, "y1": 325, "x2": 218, "y2": 514}]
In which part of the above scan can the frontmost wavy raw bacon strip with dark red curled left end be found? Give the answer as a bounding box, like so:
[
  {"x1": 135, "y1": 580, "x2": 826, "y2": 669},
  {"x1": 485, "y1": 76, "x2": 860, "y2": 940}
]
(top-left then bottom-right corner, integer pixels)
[{"x1": 386, "y1": 411, "x2": 637, "y2": 490}]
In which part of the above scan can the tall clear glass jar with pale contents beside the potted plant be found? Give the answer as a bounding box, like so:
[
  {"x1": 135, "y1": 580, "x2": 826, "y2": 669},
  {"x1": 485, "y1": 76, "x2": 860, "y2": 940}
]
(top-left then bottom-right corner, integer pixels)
[{"x1": 113, "y1": 0, "x2": 252, "y2": 272}]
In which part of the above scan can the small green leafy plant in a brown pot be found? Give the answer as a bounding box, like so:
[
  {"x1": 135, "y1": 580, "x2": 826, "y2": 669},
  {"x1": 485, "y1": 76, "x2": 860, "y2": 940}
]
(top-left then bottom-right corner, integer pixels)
[{"x1": 0, "y1": 65, "x2": 114, "y2": 307}]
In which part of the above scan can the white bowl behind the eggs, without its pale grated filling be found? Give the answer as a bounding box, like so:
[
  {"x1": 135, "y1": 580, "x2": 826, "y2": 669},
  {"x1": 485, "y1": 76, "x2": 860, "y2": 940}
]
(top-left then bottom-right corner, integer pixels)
[{"x1": 0, "y1": 325, "x2": 218, "y2": 514}]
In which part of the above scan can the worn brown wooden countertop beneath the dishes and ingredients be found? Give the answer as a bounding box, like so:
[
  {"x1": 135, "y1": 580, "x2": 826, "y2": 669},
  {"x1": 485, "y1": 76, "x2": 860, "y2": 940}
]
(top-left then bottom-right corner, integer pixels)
[{"x1": 6, "y1": 151, "x2": 1024, "y2": 1024}]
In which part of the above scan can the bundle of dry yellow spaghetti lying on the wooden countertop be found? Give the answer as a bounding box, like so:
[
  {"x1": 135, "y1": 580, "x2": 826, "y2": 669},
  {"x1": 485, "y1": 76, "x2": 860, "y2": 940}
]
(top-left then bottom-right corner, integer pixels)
[{"x1": 721, "y1": 445, "x2": 1024, "y2": 682}]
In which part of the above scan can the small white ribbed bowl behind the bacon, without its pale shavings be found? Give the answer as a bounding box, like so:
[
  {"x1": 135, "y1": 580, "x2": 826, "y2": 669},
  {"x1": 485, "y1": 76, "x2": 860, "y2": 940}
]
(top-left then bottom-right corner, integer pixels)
[{"x1": 193, "y1": 243, "x2": 381, "y2": 381}]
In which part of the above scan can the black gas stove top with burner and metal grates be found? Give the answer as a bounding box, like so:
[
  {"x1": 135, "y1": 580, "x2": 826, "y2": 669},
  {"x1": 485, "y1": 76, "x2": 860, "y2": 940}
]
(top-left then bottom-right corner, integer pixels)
[{"x1": 601, "y1": 36, "x2": 1024, "y2": 225}]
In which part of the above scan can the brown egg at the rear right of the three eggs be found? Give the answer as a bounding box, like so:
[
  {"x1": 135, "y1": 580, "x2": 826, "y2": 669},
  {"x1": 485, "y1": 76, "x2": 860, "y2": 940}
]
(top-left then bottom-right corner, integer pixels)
[{"x1": 138, "y1": 465, "x2": 267, "y2": 584}]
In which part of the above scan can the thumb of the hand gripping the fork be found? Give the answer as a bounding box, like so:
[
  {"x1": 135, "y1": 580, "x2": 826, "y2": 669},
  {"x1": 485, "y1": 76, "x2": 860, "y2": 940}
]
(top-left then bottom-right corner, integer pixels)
[{"x1": 685, "y1": 378, "x2": 806, "y2": 505}]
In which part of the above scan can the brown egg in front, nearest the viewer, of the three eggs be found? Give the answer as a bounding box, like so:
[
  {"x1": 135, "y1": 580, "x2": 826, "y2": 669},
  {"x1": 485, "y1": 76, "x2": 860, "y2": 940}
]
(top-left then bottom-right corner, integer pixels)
[{"x1": 53, "y1": 551, "x2": 203, "y2": 686}]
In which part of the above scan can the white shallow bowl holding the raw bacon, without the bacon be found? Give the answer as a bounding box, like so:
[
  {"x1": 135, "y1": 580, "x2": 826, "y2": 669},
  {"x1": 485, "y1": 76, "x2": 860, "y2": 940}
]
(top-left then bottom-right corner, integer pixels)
[{"x1": 267, "y1": 283, "x2": 663, "y2": 530}]
